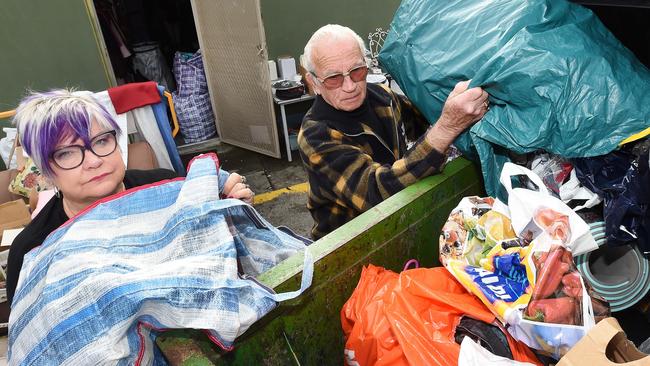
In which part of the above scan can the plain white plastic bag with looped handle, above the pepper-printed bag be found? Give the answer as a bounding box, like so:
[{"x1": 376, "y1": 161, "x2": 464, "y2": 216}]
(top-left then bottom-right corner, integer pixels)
[{"x1": 499, "y1": 163, "x2": 598, "y2": 256}]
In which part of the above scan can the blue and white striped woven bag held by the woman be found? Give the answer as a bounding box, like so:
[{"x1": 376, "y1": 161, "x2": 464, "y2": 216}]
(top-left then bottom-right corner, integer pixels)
[{"x1": 9, "y1": 155, "x2": 313, "y2": 365}]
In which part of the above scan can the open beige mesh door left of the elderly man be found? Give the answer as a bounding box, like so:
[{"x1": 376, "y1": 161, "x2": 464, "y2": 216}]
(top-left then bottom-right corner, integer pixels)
[{"x1": 192, "y1": 0, "x2": 280, "y2": 158}]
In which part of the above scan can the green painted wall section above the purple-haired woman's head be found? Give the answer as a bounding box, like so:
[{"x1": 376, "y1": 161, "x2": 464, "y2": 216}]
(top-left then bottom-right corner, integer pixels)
[{"x1": 0, "y1": 0, "x2": 109, "y2": 114}]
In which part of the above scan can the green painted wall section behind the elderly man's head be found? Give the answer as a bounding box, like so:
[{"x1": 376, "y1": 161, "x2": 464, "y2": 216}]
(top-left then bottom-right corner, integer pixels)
[{"x1": 260, "y1": 0, "x2": 400, "y2": 62}]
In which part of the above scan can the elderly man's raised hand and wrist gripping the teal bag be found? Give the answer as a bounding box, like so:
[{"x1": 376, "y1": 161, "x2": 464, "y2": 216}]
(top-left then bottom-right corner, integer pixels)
[{"x1": 426, "y1": 80, "x2": 488, "y2": 153}]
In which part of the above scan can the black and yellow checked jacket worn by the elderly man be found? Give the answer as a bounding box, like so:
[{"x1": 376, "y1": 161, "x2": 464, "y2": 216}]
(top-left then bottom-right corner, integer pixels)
[{"x1": 298, "y1": 84, "x2": 445, "y2": 239}]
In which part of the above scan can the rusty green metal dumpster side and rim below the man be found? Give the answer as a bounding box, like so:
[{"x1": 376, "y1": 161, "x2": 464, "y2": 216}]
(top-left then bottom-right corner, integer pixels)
[{"x1": 157, "y1": 158, "x2": 483, "y2": 365}]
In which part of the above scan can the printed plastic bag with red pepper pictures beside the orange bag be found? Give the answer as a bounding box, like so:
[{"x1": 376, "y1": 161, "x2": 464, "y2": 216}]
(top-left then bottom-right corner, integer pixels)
[{"x1": 439, "y1": 197, "x2": 609, "y2": 359}]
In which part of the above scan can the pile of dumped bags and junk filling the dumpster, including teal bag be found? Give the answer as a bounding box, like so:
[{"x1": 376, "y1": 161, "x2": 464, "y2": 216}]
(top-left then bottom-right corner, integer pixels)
[{"x1": 341, "y1": 0, "x2": 650, "y2": 365}]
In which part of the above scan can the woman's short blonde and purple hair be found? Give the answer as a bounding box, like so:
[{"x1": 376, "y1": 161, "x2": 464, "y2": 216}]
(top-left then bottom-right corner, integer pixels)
[{"x1": 13, "y1": 89, "x2": 121, "y2": 178}]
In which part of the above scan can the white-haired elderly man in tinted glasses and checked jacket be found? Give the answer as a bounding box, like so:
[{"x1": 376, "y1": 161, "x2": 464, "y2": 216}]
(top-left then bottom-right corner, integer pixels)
[{"x1": 298, "y1": 24, "x2": 488, "y2": 239}]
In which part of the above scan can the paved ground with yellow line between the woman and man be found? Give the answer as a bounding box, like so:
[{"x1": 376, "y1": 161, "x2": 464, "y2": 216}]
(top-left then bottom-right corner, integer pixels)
[{"x1": 182, "y1": 143, "x2": 313, "y2": 237}]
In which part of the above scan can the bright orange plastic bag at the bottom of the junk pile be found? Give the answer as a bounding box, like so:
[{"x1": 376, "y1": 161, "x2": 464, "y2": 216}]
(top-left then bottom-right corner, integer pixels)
[{"x1": 341, "y1": 265, "x2": 540, "y2": 365}]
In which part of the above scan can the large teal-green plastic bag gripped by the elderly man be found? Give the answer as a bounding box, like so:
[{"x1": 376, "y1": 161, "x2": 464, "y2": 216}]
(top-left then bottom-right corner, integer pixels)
[{"x1": 379, "y1": 0, "x2": 650, "y2": 196}]
